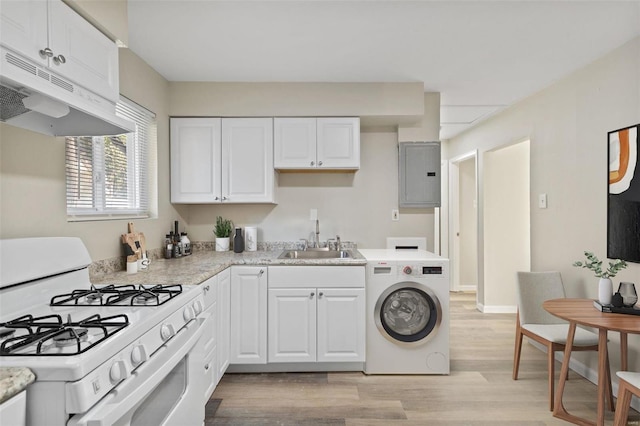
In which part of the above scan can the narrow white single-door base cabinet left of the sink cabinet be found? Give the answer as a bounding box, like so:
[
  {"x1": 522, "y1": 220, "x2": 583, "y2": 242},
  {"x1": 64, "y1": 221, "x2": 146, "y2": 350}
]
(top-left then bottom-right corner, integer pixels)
[{"x1": 229, "y1": 266, "x2": 268, "y2": 364}]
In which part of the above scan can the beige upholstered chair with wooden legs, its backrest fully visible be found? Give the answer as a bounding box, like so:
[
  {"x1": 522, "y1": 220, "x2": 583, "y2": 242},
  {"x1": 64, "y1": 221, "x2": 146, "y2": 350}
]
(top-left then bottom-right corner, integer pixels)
[{"x1": 513, "y1": 271, "x2": 613, "y2": 411}]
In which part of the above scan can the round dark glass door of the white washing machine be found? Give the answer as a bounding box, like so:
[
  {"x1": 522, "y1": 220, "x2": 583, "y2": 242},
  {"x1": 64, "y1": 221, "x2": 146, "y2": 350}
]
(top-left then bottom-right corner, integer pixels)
[{"x1": 374, "y1": 281, "x2": 442, "y2": 346}]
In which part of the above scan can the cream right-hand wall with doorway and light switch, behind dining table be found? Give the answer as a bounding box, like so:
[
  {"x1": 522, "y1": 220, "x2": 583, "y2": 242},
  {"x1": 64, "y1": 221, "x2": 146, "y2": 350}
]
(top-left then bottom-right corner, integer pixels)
[{"x1": 448, "y1": 37, "x2": 640, "y2": 371}]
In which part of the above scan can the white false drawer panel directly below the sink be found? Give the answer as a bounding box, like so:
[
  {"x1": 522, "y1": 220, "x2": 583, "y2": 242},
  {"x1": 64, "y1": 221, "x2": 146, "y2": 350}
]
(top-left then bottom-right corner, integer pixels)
[{"x1": 268, "y1": 266, "x2": 365, "y2": 288}]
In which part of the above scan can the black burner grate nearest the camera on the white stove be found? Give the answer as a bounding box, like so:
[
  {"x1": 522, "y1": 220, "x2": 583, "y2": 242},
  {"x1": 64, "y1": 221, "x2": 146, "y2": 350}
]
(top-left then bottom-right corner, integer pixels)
[{"x1": 0, "y1": 314, "x2": 129, "y2": 356}]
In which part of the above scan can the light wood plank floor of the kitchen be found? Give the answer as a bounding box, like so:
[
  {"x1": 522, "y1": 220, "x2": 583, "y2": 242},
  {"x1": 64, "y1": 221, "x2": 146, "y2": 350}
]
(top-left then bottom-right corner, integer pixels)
[{"x1": 205, "y1": 293, "x2": 640, "y2": 426}]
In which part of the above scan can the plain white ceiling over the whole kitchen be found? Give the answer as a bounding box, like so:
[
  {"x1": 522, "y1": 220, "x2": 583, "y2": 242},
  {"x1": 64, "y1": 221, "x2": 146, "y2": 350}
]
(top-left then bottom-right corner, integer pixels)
[{"x1": 128, "y1": 0, "x2": 640, "y2": 139}]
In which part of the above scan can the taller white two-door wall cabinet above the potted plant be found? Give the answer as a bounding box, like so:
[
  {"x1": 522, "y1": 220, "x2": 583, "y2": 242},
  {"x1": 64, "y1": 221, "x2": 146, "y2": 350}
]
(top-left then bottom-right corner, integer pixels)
[{"x1": 171, "y1": 118, "x2": 274, "y2": 204}]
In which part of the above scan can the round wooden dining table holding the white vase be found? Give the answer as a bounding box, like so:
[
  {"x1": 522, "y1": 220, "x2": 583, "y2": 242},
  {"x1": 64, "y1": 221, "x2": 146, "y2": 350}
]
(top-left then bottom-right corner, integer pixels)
[{"x1": 542, "y1": 298, "x2": 640, "y2": 426}]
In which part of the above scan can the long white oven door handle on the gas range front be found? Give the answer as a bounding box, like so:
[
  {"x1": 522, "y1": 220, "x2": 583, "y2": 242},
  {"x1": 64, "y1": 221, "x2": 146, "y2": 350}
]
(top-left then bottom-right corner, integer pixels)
[{"x1": 67, "y1": 320, "x2": 204, "y2": 426}]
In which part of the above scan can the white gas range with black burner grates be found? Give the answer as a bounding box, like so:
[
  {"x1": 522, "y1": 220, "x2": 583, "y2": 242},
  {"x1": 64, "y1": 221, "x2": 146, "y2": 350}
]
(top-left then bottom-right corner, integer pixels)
[{"x1": 0, "y1": 238, "x2": 206, "y2": 426}]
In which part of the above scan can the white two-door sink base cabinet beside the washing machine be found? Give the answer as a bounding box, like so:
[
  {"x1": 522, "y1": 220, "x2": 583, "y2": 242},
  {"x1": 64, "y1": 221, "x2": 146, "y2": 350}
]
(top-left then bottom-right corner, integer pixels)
[{"x1": 268, "y1": 266, "x2": 366, "y2": 363}]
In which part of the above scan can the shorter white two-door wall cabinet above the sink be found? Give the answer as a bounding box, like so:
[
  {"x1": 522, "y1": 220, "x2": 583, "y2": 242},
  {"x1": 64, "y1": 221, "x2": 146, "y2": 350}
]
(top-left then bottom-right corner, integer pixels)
[{"x1": 274, "y1": 117, "x2": 360, "y2": 170}]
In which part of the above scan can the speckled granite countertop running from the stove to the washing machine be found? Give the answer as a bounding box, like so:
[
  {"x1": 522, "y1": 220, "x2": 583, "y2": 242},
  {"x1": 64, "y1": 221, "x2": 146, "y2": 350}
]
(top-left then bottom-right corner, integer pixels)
[{"x1": 91, "y1": 249, "x2": 367, "y2": 285}]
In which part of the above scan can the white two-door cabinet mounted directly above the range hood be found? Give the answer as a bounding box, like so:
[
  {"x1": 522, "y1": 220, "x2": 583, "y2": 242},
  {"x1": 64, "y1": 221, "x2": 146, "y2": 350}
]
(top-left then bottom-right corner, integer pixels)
[{"x1": 0, "y1": 0, "x2": 119, "y2": 102}]
